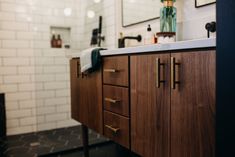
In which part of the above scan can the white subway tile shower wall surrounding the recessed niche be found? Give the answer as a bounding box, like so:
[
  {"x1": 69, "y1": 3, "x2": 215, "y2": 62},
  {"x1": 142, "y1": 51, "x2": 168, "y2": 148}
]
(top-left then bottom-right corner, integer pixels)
[{"x1": 0, "y1": 0, "x2": 81, "y2": 135}]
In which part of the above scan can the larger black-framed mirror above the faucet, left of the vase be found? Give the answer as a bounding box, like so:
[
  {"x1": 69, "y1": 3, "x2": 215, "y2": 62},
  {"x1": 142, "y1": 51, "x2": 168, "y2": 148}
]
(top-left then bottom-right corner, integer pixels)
[{"x1": 122, "y1": 0, "x2": 162, "y2": 27}]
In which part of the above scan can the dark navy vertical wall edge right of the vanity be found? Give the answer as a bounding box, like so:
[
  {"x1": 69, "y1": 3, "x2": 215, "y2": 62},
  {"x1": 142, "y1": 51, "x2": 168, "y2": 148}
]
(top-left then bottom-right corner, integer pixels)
[{"x1": 216, "y1": 0, "x2": 235, "y2": 157}]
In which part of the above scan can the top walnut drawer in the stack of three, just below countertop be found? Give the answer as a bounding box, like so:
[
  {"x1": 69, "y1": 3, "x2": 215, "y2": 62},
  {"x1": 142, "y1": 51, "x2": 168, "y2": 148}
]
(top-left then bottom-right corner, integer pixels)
[{"x1": 103, "y1": 56, "x2": 129, "y2": 87}]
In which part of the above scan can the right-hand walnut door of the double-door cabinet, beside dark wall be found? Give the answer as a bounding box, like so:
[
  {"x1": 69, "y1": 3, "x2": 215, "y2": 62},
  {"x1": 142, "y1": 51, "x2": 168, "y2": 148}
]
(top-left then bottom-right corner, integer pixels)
[{"x1": 171, "y1": 51, "x2": 216, "y2": 157}]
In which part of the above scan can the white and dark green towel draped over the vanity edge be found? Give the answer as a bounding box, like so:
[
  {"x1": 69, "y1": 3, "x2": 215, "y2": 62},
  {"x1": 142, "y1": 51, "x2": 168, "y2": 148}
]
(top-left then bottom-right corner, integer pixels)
[{"x1": 80, "y1": 47, "x2": 105, "y2": 73}]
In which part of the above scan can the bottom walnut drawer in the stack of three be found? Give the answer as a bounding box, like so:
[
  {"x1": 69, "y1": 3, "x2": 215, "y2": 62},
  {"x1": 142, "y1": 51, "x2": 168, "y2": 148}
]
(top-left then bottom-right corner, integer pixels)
[{"x1": 104, "y1": 111, "x2": 130, "y2": 148}]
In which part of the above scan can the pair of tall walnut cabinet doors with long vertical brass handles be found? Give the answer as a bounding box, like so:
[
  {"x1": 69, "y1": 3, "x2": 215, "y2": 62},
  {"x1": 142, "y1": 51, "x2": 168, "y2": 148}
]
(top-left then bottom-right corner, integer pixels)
[{"x1": 130, "y1": 51, "x2": 216, "y2": 157}]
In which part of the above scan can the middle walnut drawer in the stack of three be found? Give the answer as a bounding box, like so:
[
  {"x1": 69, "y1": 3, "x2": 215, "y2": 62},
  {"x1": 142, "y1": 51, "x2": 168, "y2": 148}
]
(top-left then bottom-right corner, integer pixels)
[{"x1": 103, "y1": 85, "x2": 129, "y2": 117}]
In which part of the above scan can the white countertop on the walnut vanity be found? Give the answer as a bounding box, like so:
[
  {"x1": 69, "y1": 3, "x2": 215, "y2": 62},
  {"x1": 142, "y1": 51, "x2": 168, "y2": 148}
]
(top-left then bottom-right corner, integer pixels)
[{"x1": 67, "y1": 38, "x2": 216, "y2": 58}]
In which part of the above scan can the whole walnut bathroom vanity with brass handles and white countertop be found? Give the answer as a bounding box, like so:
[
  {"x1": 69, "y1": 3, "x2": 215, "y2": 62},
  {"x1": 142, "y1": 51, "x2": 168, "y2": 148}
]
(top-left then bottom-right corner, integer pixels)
[{"x1": 70, "y1": 39, "x2": 216, "y2": 157}]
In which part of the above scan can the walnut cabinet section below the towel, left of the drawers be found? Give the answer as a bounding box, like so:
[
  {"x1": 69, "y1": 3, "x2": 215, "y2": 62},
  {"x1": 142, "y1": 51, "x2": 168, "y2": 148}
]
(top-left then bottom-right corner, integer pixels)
[{"x1": 70, "y1": 59, "x2": 103, "y2": 134}]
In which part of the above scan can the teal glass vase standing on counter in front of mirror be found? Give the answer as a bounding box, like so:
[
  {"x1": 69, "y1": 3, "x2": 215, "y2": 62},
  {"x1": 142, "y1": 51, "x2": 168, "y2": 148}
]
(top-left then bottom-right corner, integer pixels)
[{"x1": 160, "y1": 0, "x2": 177, "y2": 32}]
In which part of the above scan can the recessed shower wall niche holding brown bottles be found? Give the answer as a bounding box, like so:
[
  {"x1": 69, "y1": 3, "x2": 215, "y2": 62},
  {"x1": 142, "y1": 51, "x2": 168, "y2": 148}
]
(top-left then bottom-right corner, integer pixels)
[{"x1": 50, "y1": 26, "x2": 71, "y2": 49}]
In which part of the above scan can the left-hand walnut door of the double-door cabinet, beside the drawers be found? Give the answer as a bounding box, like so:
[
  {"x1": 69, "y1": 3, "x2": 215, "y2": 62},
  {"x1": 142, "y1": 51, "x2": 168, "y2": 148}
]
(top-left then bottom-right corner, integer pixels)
[{"x1": 130, "y1": 54, "x2": 170, "y2": 157}]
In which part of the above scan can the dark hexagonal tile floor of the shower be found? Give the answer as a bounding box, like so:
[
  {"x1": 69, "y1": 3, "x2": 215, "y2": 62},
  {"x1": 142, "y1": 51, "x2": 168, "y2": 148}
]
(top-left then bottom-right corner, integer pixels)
[{"x1": 0, "y1": 126, "x2": 108, "y2": 157}]
